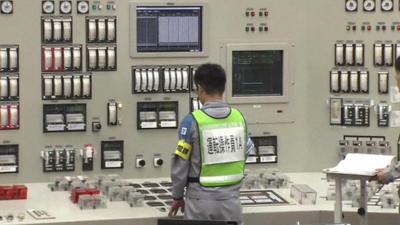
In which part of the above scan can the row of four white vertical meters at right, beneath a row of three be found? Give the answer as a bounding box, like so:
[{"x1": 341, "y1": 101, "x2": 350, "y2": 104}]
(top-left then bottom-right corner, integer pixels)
[{"x1": 330, "y1": 70, "x2": 369, "y2": 93}]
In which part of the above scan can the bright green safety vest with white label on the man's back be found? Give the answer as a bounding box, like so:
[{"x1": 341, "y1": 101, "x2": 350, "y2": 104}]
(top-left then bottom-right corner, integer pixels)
[{"x1": 192, "y1": 108, "x2": 247, "y2": 187}]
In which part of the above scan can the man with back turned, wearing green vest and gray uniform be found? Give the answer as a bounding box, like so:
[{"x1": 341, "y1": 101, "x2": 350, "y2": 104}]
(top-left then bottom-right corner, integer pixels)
[{"x1": 169, "y1": 64, "x2": 254, "y2": 225}]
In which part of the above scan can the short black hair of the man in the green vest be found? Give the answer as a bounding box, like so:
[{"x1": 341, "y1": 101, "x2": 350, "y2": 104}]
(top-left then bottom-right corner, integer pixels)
[{"x1": 194, "y1": 63, "x2": 226, "y2": 95}]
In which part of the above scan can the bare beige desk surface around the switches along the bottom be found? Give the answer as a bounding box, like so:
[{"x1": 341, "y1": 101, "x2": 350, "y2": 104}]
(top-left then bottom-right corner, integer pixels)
[{"x1": 0, "y1": 173, "x2": 398, "y2": 224}]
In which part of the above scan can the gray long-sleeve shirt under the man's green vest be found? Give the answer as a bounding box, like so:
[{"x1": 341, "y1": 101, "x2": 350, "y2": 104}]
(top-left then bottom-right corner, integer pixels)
[{"x1": 171, "y1": 101, "x2": 254, "y2": 200}]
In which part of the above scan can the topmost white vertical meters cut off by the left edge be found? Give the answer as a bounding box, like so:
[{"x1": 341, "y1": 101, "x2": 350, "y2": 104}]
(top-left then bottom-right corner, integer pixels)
[{"x1": 0, "y1": 45, "x2": 19, "y2": 72}]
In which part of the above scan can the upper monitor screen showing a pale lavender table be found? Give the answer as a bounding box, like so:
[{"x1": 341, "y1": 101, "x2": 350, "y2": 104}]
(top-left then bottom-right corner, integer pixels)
[{"x1": 136, "y1": 6, "x2": 203, "y2": 53}]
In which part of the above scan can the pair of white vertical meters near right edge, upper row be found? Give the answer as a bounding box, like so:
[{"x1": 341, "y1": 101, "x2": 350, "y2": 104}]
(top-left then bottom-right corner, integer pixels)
[{"x1": 374, "y1": 42, "x2": 400, "y2": 66}]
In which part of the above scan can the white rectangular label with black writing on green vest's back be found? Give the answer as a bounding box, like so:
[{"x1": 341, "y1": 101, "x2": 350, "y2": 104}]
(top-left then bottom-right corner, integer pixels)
[{"x1": 202, "y1": 127, "x2": 245, "y2": 165}]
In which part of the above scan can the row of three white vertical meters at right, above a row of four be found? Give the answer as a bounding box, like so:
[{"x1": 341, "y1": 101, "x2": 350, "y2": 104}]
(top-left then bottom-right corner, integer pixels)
[{"x1": 335, "y1": 42, "x2": 364, "y2": 66}]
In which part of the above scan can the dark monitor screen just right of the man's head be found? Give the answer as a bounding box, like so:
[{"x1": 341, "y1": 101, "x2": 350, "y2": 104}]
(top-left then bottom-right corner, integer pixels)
[{"x1": 232, "y1": 50, "x2": 284, "y2": 97}]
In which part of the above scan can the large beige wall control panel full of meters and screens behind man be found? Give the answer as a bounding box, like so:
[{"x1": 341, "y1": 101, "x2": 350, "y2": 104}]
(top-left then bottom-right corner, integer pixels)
[{"x1": 0, "y1": 0, "x2": 400, "y2": 183}]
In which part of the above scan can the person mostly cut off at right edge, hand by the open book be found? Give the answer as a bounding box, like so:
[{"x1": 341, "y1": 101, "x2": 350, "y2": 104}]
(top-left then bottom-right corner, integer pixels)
[{"x1": 376, "y1": 57, "x2": 400, "y2": 184}]
